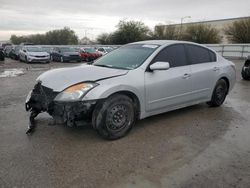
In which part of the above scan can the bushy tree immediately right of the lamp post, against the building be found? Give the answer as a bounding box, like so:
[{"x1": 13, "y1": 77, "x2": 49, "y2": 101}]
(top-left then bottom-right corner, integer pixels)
[{"x1": 181, "y1": 24, "x2": 221, "y2": 44}]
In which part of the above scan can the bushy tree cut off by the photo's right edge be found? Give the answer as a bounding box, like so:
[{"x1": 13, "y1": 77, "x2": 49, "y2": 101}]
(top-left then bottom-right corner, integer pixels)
[{"x1": 224, "y1": 18, "x2": 250, "y2": 43}]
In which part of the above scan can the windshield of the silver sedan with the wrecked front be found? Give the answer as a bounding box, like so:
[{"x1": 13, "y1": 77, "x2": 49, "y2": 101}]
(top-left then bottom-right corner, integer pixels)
[{"x1": 93, "y1": 44, "x2": 159, "y2": 70}]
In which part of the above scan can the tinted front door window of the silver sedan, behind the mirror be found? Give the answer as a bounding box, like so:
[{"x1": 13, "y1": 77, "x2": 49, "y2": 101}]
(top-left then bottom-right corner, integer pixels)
[{"x1": 153, "y1": 44, "x2": 187, "y2": 67}]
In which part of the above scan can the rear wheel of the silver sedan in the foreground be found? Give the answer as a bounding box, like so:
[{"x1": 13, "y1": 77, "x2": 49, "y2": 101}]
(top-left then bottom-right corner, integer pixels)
[{"x1": 207, "y1": 79, "x2": 228, "y2": 107}]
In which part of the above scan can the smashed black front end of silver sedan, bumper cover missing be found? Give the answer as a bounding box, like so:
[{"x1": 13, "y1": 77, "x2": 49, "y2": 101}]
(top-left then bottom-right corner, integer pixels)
[{"x1": 25, "y1": 82, "x2": 97, "y2": 133}]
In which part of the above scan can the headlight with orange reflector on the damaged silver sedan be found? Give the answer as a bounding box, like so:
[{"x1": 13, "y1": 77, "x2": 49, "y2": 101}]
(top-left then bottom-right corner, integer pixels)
[{"x1": 55, "y1": 83, "x2": 98, "y2": 101}]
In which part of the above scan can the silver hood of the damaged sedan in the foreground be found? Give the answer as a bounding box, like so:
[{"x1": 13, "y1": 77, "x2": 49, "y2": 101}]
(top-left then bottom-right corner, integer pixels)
[{"x1": 37, "y1": 65, "x2": 128, "y2": 92}]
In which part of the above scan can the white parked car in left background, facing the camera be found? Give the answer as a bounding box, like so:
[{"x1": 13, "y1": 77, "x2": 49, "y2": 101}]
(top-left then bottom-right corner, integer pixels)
[{"x1": 19, "y1": 46, "x2": 50, "y2": 63}]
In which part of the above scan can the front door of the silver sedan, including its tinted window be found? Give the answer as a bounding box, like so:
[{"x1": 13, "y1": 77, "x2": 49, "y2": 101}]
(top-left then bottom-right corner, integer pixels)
[{"x1": 145, "y1": 44, "x2": 191, "y2": 111}]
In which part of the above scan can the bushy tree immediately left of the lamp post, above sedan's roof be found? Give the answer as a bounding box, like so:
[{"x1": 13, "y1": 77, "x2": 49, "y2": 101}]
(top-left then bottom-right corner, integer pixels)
[{"x1": 153, "y1": 25, "x2": 179, "y2": 40}]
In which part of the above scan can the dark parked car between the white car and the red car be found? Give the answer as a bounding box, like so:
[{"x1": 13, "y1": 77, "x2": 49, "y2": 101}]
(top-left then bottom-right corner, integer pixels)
[{"x1": 51, "y1": 47, "x2": 81, "y2": 62}]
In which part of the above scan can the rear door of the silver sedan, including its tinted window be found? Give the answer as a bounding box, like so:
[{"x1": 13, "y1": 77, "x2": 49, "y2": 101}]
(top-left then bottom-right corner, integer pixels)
[{"x1": 185, "y1": 44, "x2": 220, "y2": 100}]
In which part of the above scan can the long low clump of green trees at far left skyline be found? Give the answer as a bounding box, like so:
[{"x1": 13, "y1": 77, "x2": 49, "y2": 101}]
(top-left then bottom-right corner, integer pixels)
[{"x1": 10, "y1": 27, "x2": 78, "y2": 45}]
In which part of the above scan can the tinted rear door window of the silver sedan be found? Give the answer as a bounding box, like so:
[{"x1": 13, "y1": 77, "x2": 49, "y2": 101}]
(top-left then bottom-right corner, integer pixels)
[{"x1": 186, "y1": 44, "x2": 211, "y2": 64}]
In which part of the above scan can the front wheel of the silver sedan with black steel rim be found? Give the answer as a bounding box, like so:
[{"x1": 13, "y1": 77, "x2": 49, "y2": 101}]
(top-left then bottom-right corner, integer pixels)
[{"x1": 92, "y1": 94, "x2": 136, "y2": 140}]
